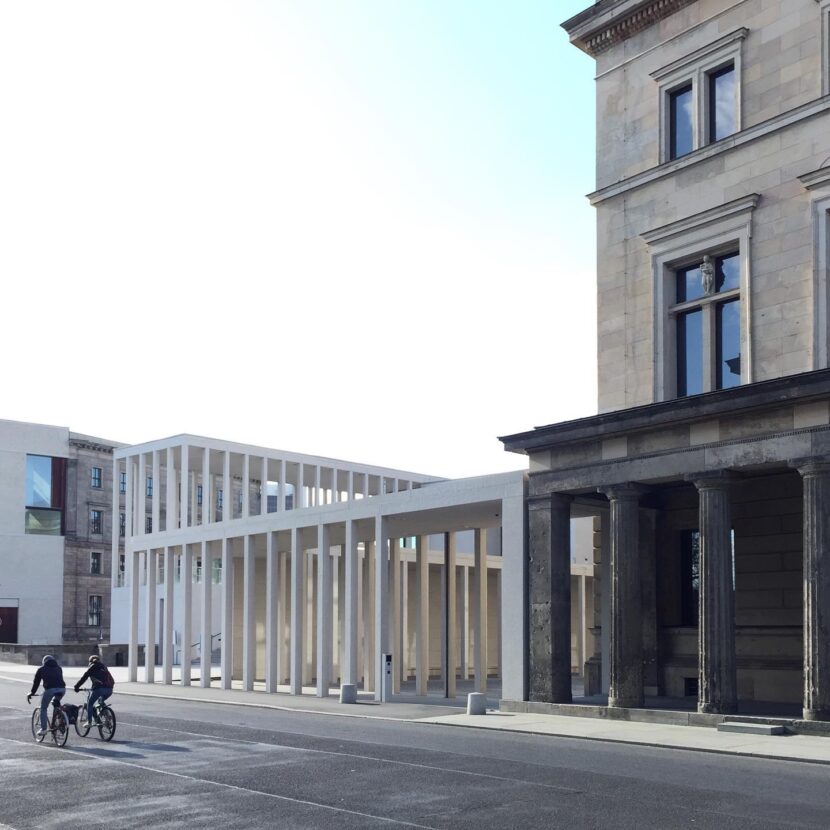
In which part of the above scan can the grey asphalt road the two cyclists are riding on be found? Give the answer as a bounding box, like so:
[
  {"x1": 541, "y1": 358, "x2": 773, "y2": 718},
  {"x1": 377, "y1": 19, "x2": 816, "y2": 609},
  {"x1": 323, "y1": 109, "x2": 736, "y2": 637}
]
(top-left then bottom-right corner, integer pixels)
[{"x1": 0, "y1": 680, "x2": 830, "y2": 830}]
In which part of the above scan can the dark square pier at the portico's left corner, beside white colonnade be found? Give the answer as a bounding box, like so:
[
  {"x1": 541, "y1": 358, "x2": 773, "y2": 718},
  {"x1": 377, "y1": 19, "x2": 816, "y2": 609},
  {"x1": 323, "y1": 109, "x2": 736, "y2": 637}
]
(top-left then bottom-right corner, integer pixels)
[{"x1": 528, "y1": 493, "x2": 572, "y2": 703}]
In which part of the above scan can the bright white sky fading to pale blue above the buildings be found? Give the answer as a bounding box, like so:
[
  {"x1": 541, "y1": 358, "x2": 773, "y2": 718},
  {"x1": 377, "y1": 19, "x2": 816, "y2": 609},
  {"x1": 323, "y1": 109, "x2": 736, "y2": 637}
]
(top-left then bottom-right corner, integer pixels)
[{"x1": 0, "y1": 0, "x2": 596, "y2": 477}]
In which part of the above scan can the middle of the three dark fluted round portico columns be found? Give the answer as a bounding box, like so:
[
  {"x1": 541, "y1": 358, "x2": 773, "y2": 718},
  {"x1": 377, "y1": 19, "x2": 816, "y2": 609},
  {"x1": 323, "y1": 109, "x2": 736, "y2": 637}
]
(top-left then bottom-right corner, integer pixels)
[{"x1": 694, "y1": 473, "x2": 738, "y2": 714}]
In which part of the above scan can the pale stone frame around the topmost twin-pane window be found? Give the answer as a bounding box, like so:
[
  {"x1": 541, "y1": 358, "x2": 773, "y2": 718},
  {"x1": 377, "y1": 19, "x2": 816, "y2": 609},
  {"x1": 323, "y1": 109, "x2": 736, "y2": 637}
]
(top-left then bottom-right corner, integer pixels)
[{"x1": 651, "y1": 28, "x2": 749, "y2": 164}]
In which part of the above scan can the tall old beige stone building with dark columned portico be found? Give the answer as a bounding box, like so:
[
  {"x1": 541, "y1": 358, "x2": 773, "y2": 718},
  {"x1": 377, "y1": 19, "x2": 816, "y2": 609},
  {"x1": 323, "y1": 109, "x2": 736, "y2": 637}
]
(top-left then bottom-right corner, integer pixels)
[{"x1": 502, "y1": 0, "x2": 830, "y2": 720}]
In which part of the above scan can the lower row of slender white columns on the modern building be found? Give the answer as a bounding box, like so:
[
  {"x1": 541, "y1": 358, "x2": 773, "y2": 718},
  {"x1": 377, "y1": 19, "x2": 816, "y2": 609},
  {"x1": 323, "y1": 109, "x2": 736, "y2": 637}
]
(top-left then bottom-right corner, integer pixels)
[{"x1": 123, "y1": 528, "x2": 501, "y2": 699}]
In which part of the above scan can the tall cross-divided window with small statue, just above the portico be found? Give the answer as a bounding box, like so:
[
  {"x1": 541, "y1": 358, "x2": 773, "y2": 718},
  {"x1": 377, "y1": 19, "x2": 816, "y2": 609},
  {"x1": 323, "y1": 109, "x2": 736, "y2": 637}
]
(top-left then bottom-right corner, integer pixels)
[{"x1": 669, "y1": 252, "x2": 741, "y2": 397}]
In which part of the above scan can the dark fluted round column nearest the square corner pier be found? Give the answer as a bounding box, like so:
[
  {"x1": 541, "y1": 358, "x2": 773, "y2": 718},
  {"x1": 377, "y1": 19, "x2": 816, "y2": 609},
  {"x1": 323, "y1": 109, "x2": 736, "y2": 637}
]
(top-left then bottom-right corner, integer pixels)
[{"x1": 605, "y1": 484, "x2": 643, "y2": 708}]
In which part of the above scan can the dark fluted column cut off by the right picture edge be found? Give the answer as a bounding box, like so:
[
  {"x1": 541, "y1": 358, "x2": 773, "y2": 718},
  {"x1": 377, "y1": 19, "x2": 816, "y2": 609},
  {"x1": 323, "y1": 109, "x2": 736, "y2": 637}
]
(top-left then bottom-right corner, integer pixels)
[{"x1": 798, "y1": 460, "x2": 830, "y2": 720}]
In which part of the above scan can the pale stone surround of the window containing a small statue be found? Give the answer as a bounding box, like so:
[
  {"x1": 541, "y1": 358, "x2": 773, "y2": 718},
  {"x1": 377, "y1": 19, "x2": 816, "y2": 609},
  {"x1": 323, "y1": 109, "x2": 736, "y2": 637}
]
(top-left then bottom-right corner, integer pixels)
[{"x1": 642, "y1": 193, "x2": 761, "y2": 401}]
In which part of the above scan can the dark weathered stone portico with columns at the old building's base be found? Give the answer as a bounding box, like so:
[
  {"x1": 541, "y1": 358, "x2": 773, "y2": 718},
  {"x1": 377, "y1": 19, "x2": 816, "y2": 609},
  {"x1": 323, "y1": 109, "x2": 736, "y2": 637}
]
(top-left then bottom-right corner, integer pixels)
[{"x1": 502, "y1": 370, "x2": 830, "y2": 720}]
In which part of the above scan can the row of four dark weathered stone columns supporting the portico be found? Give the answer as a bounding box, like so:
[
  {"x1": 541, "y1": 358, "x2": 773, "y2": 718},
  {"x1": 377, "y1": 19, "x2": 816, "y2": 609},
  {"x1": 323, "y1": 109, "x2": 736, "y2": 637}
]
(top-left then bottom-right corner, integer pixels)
[{"x1": 529, "y1": 460, "x2": 830, "y2": 720}]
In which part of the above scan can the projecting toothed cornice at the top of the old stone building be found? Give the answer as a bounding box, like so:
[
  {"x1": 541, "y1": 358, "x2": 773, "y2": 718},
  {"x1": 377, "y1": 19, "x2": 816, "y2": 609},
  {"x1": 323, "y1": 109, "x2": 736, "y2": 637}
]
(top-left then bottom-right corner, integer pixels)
[{"x1": 562, "y1": 0, "x2": 695, "y2": 57}]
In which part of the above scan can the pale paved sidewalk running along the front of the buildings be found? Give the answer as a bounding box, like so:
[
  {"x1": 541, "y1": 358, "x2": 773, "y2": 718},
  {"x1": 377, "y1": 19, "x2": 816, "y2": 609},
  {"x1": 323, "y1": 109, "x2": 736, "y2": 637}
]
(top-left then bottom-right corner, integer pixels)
[{"x1": 0, "y1": 663, "x2": 830, "y2": 765}]
